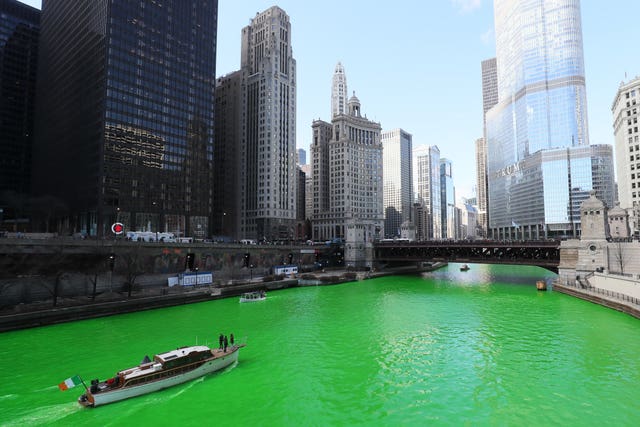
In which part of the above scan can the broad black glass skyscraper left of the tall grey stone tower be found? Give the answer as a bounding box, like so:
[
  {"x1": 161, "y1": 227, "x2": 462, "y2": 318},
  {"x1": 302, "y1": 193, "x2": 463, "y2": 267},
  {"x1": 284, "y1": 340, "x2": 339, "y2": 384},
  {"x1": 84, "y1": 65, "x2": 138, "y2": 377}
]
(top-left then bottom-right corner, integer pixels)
[{"x1": 34, "y1": 0, "x2": 218, "y2": 237}]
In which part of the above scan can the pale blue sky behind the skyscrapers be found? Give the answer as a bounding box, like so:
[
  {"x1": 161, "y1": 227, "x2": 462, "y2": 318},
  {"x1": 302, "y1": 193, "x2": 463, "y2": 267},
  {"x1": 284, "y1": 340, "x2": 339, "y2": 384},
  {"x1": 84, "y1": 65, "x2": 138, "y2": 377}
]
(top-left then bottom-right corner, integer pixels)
[{"x1": 17, "y1": 0, "x2": 640, "y2": 201}]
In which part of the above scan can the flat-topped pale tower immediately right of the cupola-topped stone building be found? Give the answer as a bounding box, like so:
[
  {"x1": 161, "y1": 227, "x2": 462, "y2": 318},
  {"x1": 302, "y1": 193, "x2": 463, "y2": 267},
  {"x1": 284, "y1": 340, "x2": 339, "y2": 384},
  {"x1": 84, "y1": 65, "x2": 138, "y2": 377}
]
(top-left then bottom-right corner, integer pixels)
[{"x1": 382, "y1": 129, "x2": 413, "y2": 238}]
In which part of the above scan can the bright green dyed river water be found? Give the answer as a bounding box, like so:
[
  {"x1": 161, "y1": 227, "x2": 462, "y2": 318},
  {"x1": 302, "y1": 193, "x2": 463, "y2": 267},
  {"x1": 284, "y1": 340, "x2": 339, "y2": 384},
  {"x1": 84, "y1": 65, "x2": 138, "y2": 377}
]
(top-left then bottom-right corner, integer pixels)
[{"x1": 0, "y1": 264, "x2": 640, "y2": 426}]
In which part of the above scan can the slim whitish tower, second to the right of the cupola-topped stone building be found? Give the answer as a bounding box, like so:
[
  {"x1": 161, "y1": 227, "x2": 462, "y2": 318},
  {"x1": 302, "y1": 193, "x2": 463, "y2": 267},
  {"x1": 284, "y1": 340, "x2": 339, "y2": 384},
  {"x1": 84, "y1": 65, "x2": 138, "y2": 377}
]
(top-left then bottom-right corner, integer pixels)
[{"x1": 413, "y1": 145, "x2": 442, "y2": 240}]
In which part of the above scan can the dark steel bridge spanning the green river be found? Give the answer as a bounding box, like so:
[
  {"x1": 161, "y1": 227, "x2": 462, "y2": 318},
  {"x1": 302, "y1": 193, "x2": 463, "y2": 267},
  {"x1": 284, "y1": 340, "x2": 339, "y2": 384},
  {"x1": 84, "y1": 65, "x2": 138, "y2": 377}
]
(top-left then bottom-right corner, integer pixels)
[{"x1": 374, "y1": 240, "x2": 560, "y2": 273}]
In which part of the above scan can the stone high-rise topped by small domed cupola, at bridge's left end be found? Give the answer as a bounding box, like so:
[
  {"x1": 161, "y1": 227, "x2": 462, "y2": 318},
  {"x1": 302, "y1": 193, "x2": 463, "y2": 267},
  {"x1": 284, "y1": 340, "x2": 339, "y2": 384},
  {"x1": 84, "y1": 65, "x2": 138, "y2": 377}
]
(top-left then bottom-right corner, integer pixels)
[{"x1": 311, "y1": 95, "x2": 384, "y2": 247}]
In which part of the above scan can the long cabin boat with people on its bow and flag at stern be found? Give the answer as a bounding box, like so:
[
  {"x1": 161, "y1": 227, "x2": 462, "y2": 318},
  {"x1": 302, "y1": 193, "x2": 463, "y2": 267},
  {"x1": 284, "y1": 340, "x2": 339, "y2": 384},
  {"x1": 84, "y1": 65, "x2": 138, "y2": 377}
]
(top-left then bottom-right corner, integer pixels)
[{"x1": 78, "y1": 344, "x2": 245, "y2": 407}]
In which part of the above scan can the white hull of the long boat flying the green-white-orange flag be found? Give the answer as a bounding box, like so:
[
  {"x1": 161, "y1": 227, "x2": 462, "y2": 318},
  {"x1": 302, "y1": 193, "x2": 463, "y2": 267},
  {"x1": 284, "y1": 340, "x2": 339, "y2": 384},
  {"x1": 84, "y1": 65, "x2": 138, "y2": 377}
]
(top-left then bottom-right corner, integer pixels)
[{"x1": 78, "y1": 348, "x2": 239, "y2": 407}]
